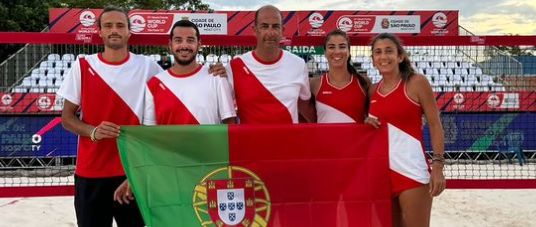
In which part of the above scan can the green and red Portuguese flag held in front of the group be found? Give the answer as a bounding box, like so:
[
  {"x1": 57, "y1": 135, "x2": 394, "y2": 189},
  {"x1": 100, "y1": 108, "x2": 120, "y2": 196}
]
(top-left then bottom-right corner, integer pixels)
[{"x1": 118, "y1": 124, "x2": 391, "y2": 227}]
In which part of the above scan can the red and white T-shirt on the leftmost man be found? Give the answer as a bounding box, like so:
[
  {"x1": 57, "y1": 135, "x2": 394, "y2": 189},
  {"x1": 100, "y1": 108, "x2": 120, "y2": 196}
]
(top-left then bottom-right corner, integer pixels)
[{"x1": 58, "y1": 53, "x2": 162, "y2": 178}]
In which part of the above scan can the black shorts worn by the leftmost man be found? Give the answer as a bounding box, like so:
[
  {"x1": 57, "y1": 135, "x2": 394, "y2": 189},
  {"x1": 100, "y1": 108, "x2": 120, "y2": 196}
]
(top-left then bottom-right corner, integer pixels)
[{"x1": 74, "y1": 175, "x2": 145, "y2": 227}]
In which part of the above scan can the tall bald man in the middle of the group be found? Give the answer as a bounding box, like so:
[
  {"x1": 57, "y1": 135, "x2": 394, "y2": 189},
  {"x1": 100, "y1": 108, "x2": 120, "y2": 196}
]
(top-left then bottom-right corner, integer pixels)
[{"x1": 228, "y1": 5, "x2": 314, "y2": 124}]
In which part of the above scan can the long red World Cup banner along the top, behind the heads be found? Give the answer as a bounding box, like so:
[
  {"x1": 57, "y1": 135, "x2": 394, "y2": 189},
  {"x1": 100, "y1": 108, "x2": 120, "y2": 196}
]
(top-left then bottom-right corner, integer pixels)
[{"x1": 49, "y1": 8, "x2": 458, "y2": 38}]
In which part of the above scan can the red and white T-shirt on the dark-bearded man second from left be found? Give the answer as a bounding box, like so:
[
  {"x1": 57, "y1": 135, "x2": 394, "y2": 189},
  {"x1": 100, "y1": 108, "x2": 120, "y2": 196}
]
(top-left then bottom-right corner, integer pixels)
[{"x1": 143, "y1": 65, "x2": 236, "y2": 125}]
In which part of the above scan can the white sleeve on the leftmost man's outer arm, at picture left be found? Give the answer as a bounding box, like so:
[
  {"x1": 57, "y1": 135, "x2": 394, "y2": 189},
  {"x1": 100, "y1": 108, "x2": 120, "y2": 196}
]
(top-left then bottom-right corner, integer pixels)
[{"x1": 57, "y1": 59, "x2": 82, "y2": 106}]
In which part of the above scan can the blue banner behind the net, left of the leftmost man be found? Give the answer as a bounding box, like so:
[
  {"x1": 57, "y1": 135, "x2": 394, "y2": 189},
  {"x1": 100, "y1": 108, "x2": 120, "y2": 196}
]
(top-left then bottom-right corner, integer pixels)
[{"x1": 0, "y1": 115, "x2": 78, "y2": 158}]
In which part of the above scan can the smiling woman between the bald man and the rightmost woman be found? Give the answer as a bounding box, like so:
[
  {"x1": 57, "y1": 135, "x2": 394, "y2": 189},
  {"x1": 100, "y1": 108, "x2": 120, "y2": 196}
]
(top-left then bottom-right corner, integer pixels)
[{"x1": 310, "y1": 29, "x2": 370, "y2": 124}]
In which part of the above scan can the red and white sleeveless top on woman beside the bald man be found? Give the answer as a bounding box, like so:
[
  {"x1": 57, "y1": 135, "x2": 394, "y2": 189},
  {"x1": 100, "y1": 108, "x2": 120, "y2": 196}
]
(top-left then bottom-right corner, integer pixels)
[{"x1": 316, "y1": 73, "x2": 366, "y2": 124}]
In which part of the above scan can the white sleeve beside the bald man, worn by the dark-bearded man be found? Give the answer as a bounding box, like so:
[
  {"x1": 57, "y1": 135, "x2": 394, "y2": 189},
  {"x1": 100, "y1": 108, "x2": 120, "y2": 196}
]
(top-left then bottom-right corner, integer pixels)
[{"x1": 214, "y1": 77, "x2": 236, "y2": 120}]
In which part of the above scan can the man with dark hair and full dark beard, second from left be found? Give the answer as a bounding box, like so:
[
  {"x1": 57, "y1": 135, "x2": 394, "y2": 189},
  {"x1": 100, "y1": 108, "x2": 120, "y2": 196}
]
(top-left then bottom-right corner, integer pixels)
[{"x1": 143, "y1": 20, "x2": 236, "y2": 125}]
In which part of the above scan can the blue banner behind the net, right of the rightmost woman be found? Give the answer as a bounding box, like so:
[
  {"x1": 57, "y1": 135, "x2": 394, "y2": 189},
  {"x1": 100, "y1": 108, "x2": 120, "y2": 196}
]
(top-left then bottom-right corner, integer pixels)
[{"x1": 424, "y1": 112, "x2": 536, "y2": 152}]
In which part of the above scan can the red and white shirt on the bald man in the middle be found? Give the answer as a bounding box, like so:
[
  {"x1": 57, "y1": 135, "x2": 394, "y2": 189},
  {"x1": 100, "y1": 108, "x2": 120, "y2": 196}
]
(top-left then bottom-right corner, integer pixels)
[{"x1": 227, "y1": 50, "x2": 311, "y2": 124}]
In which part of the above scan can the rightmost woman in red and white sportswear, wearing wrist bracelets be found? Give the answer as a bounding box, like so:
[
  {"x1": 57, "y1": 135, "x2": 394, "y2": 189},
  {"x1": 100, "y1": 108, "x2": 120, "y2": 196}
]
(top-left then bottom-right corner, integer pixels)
[{"x1": 365, "y1": 33, "x2": 445, "y2": 226}]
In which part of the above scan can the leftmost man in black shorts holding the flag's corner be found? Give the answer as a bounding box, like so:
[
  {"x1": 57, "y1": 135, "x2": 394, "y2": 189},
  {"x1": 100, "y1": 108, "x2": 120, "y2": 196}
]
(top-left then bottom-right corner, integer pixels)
[{"x1": 58, "y1": 7, "x2": 162, "y2": 227}]
